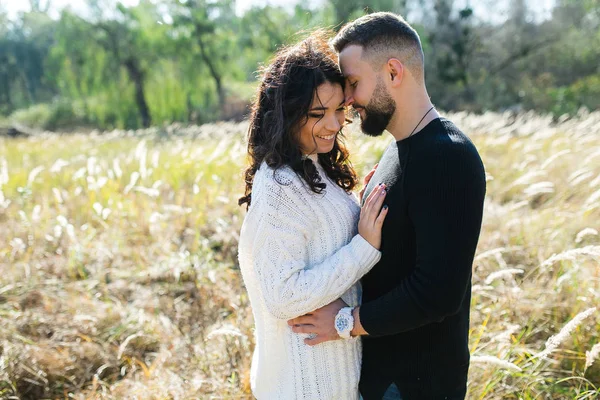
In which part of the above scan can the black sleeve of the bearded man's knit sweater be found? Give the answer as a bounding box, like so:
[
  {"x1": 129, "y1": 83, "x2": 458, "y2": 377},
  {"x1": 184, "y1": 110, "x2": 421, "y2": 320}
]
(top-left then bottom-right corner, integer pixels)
[{"x1": 360, "y1": 142, "x2": 485, "y2": 336}]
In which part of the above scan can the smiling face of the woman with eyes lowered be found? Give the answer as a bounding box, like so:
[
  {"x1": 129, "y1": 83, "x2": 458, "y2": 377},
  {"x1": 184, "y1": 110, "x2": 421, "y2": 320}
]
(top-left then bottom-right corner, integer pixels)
[{"x1": 300, "y1": 82, "x2": 346, "y2": 155}]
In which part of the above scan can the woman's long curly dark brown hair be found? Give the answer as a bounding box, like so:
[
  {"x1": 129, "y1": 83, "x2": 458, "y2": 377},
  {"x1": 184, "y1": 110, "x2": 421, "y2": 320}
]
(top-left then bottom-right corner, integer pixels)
[{"x1": 238, "y1": 31, "x2": 357, "y2": 207}]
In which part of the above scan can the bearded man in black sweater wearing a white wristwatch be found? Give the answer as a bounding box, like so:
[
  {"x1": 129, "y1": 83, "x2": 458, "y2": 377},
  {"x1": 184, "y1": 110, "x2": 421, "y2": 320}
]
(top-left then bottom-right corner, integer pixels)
[{"x1": 289, "y1": 13, "x2": 485, "y2": 400}]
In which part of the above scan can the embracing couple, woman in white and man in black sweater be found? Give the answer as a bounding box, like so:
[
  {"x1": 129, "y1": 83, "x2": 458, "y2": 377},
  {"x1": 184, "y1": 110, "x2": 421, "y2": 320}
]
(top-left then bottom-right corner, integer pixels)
[{"x1": 239, "y1": 13, "x2": 485, "y2": 400}]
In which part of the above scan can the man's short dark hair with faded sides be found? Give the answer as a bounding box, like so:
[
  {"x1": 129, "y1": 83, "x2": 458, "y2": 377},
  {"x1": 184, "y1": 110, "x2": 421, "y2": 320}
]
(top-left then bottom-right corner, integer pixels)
[{"x1": 331, "y1": 12, "x2": 424, "y2": 80}]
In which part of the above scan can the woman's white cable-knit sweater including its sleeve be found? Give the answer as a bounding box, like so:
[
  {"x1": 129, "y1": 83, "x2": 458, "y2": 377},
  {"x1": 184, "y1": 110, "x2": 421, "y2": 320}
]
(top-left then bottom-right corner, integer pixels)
[{"x1": 239, "y1": 158, "x2": 381, "y2": 400}]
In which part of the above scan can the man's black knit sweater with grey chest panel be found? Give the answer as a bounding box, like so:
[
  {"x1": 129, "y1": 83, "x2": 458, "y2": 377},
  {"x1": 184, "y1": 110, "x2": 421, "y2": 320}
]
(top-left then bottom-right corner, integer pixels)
[{"x1": 360, "y1": 118, "x2": 485, "y2": 400}]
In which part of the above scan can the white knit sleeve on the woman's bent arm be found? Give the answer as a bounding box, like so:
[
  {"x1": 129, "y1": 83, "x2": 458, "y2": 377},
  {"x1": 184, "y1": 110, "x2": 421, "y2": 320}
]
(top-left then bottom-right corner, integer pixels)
[{"x1": 248, "y1": 172, "x2": 381, "y2": 319}]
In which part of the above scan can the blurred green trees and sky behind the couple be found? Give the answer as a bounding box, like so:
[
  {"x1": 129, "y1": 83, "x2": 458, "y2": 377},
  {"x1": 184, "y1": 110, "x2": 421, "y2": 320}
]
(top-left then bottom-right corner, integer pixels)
[{"x1": 0, "y1": 0, "x2": 600, "y2": 130}]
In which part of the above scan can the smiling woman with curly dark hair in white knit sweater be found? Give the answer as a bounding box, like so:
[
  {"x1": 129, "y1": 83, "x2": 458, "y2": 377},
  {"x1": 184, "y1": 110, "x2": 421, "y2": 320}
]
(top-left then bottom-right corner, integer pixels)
[{"x1": 239, "y1": 34, "x2": 387, "y2": 400}]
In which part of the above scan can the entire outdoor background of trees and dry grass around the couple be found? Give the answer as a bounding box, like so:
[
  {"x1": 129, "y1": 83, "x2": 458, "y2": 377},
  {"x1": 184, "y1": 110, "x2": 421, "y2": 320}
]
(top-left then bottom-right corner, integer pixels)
[{"x1": 0, "y1": 0, "x2": 600, "y2": 400}]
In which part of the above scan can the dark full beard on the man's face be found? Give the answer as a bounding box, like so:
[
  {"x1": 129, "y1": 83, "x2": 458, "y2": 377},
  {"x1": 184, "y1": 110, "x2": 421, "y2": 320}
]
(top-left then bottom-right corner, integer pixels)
[{"x1": 360, "y1": 78, "x2": 396, "y2": 137}]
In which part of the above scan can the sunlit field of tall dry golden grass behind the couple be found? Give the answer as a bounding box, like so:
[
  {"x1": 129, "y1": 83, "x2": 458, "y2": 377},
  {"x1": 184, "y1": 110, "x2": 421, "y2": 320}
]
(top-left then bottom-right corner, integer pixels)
[{"x1": 0, "y1": 113, "x2": 600, "y2": 400}]
